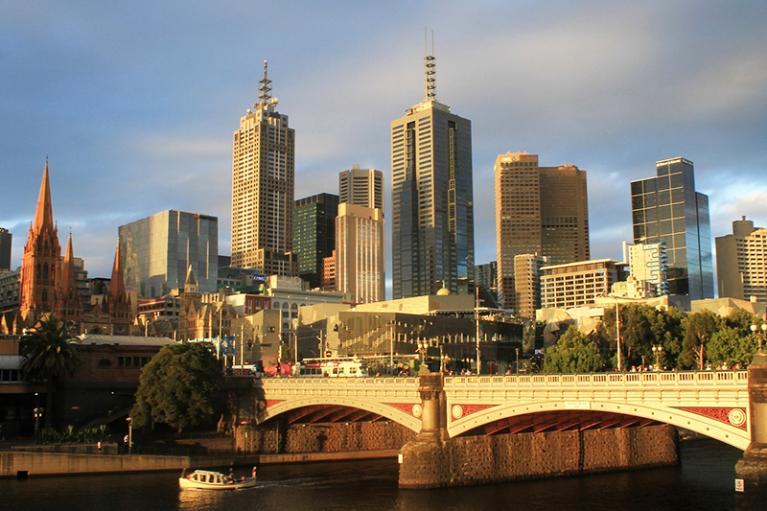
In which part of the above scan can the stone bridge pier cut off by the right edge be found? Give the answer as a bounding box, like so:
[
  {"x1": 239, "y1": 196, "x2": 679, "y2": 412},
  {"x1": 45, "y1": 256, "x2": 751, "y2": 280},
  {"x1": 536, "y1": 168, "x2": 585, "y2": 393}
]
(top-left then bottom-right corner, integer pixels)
[{"x1": 735, "y1": 347, "x2": 767, "y2": 499}]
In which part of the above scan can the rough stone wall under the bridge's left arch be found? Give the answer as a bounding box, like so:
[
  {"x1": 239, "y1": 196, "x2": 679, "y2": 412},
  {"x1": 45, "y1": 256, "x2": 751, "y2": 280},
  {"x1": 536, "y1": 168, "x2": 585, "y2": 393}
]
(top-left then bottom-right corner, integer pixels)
[{"x1": 235, "y1": 421, "x2": 415, "y2": 454}]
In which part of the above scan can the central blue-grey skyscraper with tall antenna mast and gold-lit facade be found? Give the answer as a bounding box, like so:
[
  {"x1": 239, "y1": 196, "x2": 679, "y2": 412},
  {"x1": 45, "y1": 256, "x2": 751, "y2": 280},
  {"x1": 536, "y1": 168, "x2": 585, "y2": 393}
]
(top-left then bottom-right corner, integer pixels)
[{"x1": 391, "y1": 50, "x2": 474, "y2": 298}]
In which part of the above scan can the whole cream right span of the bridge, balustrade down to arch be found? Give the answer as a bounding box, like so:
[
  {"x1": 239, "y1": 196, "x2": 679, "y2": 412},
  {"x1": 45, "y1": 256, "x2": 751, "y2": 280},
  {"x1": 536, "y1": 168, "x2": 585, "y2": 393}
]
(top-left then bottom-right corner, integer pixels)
[{"x1": 444, "y1": 371, "x2": 750, "y2": 449}]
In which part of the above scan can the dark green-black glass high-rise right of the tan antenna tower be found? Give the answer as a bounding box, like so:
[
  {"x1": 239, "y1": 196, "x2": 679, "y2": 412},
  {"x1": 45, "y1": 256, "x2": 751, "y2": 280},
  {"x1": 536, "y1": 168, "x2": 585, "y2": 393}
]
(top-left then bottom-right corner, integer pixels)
[{"x1": 293, "y1": 193, "x2": 338, "y2": 288}]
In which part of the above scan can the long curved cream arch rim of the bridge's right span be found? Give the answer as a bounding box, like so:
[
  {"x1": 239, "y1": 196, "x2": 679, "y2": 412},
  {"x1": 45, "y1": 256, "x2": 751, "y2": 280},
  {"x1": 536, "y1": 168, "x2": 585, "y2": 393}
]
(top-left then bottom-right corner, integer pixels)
[{"x1": 448, "y1": 400, "x2": 750, "y2": 450}]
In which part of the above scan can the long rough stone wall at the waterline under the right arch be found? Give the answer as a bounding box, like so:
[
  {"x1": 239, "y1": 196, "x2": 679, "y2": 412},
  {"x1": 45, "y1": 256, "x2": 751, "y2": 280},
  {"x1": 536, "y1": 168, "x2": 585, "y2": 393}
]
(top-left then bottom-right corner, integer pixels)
[{"x1": 399, "y1": 425, "x2": 679, "y2": 488}]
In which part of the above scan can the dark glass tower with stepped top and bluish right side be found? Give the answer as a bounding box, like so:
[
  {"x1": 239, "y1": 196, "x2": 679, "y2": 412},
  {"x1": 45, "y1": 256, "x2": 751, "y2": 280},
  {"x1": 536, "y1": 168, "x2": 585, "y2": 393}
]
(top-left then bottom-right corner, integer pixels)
[{"x1": 631, "y1": 157, "x2": 714, "y2": 300}]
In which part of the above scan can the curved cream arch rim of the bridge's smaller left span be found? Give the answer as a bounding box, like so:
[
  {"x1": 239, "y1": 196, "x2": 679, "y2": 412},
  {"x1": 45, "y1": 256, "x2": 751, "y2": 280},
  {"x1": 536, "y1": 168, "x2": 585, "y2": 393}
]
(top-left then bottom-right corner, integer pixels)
[{"x1": 259, "y1": 396, "x2": 421, "y2": 433}]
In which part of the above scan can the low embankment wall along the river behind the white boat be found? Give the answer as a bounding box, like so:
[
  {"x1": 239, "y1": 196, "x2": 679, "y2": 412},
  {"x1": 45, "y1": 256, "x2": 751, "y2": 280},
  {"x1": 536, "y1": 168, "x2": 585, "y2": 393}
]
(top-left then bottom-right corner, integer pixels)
[{"x1": 0, "y1": 449, "x2": 399, "y2": 478}]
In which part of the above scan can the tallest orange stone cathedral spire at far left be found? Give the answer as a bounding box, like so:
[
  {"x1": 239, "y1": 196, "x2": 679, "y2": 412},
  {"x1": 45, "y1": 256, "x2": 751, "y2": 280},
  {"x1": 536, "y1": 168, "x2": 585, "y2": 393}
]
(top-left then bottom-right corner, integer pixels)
[{"x1": 19, "y1": 160, "x2": 61, "y2": 323}]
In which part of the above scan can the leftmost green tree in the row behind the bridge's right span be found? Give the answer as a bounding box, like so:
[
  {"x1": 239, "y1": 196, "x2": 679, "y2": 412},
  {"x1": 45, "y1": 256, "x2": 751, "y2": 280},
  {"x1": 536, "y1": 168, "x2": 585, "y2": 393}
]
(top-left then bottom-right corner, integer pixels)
[{"x1": 543, "y1": 326, "x2": 604, "y2": 373}]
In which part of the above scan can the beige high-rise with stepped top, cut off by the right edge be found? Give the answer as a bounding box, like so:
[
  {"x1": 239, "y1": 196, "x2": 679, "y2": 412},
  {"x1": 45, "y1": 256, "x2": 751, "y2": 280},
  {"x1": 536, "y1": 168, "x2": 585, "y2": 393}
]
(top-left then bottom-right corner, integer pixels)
[{"x1": 716, "y1": 217, "x2": 767, "y2": 303}]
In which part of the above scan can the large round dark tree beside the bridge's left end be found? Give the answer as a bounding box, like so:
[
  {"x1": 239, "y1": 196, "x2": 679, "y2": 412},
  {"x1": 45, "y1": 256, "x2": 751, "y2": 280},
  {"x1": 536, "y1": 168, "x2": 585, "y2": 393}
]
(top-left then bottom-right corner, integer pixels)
[{"x1": 131, "y1": 343, "x2": 223, "y2": 433}]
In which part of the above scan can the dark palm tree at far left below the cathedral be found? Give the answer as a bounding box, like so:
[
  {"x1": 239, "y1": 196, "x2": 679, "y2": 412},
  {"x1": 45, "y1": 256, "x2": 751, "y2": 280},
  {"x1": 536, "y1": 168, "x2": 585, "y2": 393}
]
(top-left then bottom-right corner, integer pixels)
[{"x1": 19, "y1": 316, "x2": 77, "y2": 427}]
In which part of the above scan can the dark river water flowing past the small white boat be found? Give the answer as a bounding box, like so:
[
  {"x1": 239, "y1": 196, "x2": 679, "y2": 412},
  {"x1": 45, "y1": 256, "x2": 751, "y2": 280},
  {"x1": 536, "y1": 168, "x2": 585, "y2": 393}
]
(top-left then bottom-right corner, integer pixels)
[{"x1": 0, "y1": 440, "x2": 752, "y2": 511}]
